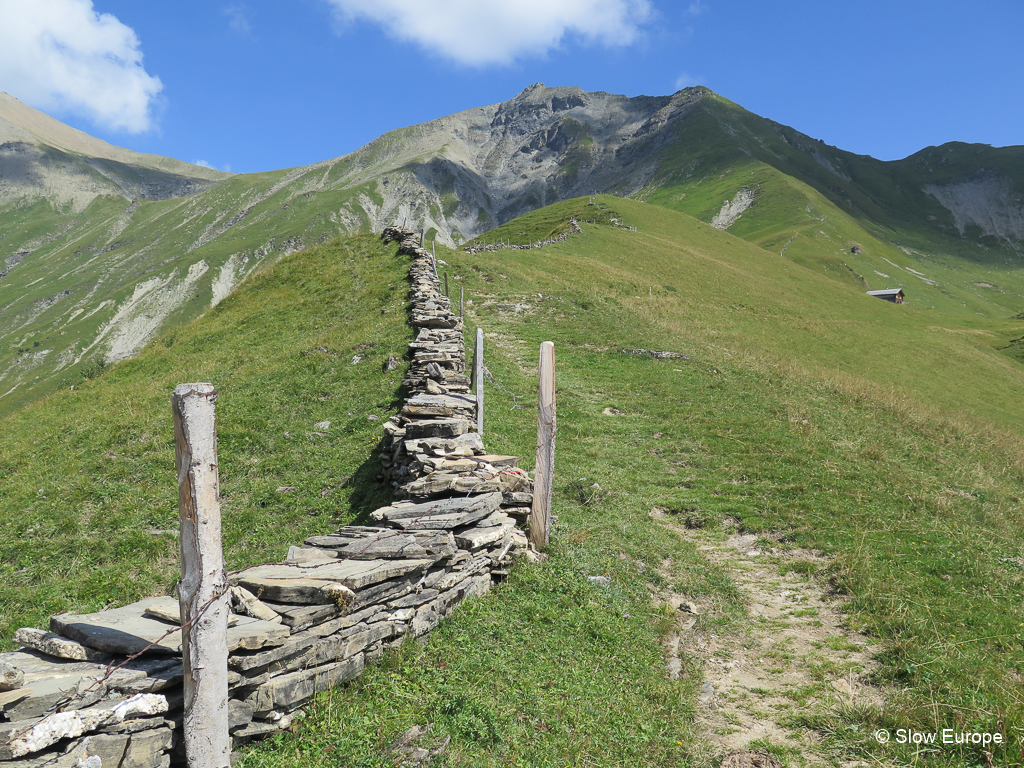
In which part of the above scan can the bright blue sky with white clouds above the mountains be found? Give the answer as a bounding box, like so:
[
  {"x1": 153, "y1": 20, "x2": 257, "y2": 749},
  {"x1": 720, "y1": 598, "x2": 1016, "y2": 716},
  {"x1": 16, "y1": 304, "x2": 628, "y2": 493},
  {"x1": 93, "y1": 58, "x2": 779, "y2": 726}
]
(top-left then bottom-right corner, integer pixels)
[{"x1": 0, "y1": 0, "x2": 1024, "y2": 172}]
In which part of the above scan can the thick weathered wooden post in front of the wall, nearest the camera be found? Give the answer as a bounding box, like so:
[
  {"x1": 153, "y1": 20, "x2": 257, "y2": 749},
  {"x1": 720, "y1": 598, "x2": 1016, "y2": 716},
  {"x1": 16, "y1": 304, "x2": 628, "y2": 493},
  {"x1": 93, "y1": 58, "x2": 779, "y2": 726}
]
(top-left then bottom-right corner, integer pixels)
[{"x1": 171, "y1": 384, "x2": 231, "y2": 768}]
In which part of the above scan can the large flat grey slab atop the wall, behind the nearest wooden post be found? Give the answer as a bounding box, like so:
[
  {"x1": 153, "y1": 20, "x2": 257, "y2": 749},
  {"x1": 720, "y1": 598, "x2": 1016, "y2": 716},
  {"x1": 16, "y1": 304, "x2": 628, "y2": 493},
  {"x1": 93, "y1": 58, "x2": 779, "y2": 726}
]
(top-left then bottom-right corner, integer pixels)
[{"x1": 50, "y1": 597, "x2": 289, "y2": 655}]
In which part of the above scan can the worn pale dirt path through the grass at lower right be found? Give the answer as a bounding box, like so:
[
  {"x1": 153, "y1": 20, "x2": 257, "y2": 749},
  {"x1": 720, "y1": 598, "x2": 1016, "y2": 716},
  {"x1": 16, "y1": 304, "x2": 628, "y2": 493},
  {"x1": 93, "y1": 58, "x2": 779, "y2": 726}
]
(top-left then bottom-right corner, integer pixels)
[{"x1": 652, "y1": 518, "x2": 883, "y2": 768}]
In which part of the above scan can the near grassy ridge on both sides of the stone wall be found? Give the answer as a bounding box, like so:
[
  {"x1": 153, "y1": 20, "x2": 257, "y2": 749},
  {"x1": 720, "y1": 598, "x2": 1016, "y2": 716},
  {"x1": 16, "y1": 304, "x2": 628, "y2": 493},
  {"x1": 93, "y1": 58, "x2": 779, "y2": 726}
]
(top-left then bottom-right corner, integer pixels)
[{"x1": 0, "y1": 201, "x2": 1024, "y2": 768}]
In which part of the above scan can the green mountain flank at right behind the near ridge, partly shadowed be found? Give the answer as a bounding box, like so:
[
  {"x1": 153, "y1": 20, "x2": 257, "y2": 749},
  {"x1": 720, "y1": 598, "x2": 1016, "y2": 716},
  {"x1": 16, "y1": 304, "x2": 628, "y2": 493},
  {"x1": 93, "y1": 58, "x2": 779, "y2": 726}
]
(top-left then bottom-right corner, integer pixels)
[{"x1": 635, "y1": 93, "x2": 1024, "y2": 327}]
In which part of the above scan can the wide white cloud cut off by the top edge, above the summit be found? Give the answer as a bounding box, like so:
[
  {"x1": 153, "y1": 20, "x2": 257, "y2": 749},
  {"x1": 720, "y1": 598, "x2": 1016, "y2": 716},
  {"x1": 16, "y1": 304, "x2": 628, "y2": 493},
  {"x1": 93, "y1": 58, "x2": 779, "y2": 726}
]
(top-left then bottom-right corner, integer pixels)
[{"x1": 328, "y1": 0, "x2": 653, "y2": 66}]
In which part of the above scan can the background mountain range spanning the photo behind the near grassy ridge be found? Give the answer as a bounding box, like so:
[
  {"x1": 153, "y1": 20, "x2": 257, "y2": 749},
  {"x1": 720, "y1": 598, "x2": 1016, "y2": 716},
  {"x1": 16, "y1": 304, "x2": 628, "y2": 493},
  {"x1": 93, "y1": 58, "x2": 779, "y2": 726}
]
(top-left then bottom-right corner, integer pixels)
[{"x1": 0, "y1": 84, "x2": 1024, "y2": 410}]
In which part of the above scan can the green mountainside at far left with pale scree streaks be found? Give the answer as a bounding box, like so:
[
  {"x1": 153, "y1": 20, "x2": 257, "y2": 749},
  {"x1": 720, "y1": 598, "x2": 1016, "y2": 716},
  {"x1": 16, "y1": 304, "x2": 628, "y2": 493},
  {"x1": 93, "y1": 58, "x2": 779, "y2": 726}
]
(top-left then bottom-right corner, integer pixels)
[{"x1": 0, "y1": 169, "x2": 387, "y2": 410}]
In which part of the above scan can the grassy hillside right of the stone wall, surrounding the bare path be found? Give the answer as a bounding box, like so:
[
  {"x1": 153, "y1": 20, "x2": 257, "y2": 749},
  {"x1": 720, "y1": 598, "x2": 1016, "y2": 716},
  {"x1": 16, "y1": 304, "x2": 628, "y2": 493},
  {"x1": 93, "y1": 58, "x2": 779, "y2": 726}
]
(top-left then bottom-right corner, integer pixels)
[{"x1": 239, "y1": 198, "x2": 1024, "y2": 768}]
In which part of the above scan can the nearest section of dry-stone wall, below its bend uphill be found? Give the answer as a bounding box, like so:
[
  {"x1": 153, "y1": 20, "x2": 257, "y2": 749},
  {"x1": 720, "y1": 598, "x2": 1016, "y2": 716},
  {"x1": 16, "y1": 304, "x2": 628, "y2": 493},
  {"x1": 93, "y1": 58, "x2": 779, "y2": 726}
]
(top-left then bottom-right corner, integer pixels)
[{"x1": 0, "y1": 528, "x2": 512, "y2": 768}]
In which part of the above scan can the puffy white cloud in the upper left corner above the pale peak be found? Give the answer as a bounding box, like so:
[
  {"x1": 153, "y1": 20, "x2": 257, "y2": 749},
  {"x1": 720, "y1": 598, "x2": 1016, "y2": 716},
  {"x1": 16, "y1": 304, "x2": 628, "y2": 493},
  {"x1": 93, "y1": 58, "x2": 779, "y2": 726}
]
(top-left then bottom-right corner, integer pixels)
[{"x1": 0, "y1": 0, "x2": 164, "y2": 133}]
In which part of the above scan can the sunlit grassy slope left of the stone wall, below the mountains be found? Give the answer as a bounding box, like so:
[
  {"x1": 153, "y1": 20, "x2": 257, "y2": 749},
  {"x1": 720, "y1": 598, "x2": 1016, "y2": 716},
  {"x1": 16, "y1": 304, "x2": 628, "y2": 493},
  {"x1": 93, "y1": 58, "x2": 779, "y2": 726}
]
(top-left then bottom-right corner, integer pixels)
[{"x1": 0, "y1": 236, "x2": 409, "y2": 647}]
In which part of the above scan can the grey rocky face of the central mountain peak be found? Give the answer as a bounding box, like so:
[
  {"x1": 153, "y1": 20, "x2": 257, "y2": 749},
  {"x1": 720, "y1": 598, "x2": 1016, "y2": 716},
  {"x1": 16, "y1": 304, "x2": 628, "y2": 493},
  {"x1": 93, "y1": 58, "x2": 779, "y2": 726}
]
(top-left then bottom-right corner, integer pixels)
[{"x1": 336, "y1": 84, "x2": 710, "y2": 245}]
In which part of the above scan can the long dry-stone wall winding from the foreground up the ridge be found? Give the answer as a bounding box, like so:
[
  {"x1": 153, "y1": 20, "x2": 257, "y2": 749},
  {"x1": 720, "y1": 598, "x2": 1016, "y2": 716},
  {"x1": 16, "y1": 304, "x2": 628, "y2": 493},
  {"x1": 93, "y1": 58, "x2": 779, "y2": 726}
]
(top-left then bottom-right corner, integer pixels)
[{"x1": 0, "y1": 228, "x2": 532, "y2": 768}]
